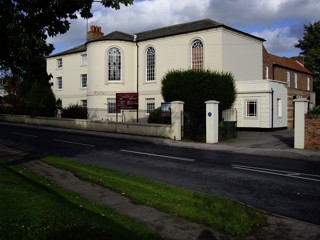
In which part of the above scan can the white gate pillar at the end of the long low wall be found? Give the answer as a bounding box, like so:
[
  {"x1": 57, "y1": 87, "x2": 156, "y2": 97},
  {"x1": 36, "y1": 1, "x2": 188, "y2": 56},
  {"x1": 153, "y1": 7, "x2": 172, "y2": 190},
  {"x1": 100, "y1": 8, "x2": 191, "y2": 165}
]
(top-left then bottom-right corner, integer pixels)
[{"x1": 171, "y1": 101, "x2": 184, "y2": 140}]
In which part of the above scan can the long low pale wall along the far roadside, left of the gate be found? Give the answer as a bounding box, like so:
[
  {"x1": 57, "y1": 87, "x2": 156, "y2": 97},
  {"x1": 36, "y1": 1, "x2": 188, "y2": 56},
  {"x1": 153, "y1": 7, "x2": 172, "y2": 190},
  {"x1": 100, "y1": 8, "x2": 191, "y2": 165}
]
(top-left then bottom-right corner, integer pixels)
[{"x1": 0, "y1": 114, "x2": 175, "y2": 139}]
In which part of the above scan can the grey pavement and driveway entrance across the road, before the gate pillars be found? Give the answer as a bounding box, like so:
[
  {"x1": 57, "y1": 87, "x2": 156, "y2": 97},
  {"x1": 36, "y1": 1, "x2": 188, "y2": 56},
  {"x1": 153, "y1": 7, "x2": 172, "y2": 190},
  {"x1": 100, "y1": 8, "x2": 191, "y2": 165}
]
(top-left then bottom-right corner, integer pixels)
[{"x1": 115, "y1": 129, "x2": 320, "y2": 162}]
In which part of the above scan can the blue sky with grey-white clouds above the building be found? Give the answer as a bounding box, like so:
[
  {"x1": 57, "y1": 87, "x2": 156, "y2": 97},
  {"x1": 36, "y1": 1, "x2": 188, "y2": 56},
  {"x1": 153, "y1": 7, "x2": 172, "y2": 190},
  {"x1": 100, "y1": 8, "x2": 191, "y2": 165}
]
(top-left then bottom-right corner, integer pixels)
[{"x1": 48, "y1": 0, "x2": 320, "y2": 57}]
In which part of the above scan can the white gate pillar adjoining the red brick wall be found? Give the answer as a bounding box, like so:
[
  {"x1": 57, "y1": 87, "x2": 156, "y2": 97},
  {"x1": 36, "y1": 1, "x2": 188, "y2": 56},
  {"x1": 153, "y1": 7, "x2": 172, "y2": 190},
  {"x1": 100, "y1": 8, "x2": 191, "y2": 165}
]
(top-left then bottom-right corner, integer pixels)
[{"x1": 293, "y1": 98, "x2": 309, "y2": 149}]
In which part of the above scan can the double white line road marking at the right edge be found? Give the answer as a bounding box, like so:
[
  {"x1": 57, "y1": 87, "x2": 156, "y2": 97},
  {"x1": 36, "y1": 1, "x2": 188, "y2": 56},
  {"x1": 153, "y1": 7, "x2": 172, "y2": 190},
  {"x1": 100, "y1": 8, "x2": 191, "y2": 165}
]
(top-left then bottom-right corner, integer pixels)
[{"x1": 231, "y1": 164, "x2": 320, "y2": 182}]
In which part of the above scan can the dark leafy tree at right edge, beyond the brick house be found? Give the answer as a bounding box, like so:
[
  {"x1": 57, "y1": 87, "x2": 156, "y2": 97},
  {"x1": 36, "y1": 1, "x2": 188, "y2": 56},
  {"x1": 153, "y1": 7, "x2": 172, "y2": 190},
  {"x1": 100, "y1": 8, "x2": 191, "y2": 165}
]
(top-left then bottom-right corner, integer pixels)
[{"x1": 295, "y1": 21, "x2": 320, "y2": 105}]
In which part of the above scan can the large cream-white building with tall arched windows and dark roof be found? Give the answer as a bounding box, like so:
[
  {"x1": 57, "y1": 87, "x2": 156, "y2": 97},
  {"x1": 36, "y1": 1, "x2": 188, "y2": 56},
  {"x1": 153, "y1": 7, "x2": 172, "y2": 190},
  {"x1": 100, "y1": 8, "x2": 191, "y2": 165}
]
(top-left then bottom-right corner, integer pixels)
[{"x1": 47, "y1": 19, "x2": 287, "y2": 128}]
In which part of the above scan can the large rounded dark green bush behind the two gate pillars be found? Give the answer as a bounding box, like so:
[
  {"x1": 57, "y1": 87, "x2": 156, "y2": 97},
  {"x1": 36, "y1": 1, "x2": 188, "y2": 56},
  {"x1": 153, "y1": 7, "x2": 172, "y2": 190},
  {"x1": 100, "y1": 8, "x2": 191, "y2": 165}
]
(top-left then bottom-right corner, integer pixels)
[{"x1": 161, "y1": 70, "x2": 236, "y2": 112}]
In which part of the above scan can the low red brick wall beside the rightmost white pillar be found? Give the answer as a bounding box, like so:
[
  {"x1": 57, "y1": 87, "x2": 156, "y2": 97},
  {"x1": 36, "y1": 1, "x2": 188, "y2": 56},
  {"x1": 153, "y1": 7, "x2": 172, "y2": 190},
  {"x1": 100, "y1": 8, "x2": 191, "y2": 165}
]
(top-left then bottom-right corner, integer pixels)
[{"x1": 304, "y1": 115, "x2": 320, "y2": 149}]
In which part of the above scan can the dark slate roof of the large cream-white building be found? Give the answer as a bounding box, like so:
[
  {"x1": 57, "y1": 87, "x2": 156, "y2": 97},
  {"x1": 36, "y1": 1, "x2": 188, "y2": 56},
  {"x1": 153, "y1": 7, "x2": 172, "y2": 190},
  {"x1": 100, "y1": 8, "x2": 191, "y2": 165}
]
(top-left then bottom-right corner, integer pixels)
[{"x1": 49, "y1": 19, "x2": 265, "y2": 57}]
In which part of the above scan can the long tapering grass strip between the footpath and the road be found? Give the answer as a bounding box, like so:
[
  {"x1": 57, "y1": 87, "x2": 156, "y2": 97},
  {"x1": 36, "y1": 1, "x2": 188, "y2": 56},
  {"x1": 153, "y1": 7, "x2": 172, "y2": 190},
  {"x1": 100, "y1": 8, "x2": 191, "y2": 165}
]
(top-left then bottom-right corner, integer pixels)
[{"x1": 43, "y1": 157, "x2": 265, "y2": 237}]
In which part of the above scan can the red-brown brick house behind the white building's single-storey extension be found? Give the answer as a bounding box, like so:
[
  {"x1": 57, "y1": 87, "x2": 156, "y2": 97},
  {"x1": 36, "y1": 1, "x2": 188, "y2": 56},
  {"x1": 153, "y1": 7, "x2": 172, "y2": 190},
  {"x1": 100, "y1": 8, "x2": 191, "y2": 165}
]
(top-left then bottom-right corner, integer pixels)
[{"x1": 263, "y1": 48, "x2": 315, "y2": 128}]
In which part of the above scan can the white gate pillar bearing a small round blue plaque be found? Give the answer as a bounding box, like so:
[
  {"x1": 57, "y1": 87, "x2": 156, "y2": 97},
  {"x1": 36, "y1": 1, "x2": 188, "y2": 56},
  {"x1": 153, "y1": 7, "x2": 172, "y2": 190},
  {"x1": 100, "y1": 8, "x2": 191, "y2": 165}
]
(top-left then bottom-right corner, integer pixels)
[{"x1": 205, "y1": 100, "x2": 219, "y2": 143}]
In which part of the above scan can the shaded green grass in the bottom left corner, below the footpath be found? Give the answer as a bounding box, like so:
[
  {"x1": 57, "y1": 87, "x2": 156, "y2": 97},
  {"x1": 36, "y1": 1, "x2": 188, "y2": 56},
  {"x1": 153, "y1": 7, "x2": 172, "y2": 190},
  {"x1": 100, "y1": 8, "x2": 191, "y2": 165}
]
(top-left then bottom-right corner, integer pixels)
[{"x1": 0, "y1": 161, "x2": 163, "y2": 240}]
